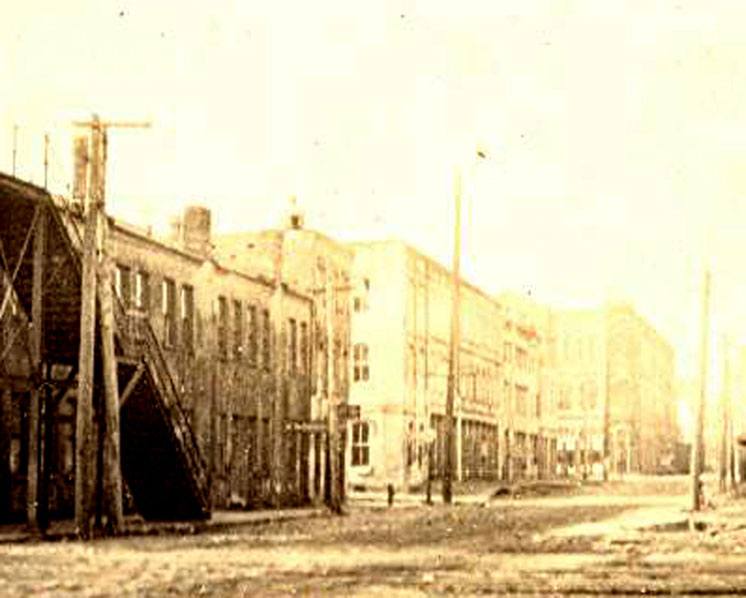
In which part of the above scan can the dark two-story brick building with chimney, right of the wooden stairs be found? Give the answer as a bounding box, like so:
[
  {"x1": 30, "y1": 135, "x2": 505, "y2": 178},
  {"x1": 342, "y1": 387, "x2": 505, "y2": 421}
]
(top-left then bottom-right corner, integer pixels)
[{"x1": 111, "y1": 207, "x2": 313, "y2": 506}]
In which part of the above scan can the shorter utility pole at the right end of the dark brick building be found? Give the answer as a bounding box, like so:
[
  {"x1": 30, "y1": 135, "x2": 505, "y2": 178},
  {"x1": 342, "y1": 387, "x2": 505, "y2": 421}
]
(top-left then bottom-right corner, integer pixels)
[{"x1": 324, "y1": 259, "x2": 342, "y2": 513}]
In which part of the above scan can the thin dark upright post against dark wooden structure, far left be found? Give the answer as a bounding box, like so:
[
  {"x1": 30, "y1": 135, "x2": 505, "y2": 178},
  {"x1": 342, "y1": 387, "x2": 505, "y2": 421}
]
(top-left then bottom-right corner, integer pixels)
[{"x1": 26, "y1": 207, "x2": 47, "y2": 532}]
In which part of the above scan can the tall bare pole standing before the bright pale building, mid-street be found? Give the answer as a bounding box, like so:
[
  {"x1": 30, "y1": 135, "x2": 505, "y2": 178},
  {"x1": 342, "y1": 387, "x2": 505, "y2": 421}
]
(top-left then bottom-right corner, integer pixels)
[{"x1": 443, "y1": 170, "x2": 461, "y2": 504}]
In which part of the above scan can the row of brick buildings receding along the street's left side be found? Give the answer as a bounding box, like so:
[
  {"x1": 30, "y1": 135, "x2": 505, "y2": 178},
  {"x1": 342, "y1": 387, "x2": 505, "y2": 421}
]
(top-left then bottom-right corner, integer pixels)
[{"x1": 0, "y1": 180, "x2": 678, "y2": 524}]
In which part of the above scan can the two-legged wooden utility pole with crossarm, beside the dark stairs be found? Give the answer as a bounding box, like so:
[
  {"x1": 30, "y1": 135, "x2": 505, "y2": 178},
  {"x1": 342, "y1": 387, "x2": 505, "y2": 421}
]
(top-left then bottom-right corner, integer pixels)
[{"x1": 74, "y1": 115, "x2": 150, "y2": 539}]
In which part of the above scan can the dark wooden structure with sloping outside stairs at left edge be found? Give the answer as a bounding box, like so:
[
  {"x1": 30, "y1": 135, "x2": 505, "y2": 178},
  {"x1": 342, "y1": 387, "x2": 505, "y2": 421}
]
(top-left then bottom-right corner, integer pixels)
[{"x1": 0, "y1": 175, "x2": 211, "y2": 529}]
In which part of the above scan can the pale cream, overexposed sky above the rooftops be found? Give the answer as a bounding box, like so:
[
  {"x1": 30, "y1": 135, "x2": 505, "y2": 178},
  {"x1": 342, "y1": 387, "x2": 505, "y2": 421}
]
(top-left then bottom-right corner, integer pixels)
[{"x1": 0, "y1": 0, "x2": 746, "y2": 390}]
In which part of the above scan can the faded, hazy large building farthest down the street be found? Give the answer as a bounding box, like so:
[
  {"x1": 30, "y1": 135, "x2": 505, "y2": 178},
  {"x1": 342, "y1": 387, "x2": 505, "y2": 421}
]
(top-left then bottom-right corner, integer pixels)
[{"x1": 550, "y1": 304, "x2": 679, "y2": 475}]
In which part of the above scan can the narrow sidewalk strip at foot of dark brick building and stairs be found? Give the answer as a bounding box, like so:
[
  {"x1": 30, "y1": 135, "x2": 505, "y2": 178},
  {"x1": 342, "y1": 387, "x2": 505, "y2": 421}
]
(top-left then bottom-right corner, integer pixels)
[{"x1": 0, "y1": 507, "x2": 328, "y2": 544}]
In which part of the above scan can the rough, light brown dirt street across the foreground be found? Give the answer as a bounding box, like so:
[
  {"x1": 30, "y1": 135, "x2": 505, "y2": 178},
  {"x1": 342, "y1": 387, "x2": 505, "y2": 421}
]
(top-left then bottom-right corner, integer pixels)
[{"x1": 0, "y1": 480, "x2": 746, "y2": 596}]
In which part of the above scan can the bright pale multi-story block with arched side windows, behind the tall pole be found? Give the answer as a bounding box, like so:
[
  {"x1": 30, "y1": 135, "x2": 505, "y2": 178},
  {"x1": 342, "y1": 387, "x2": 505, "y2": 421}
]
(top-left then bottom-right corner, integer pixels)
[{"x1": 348, "y1": 241, "x2": 552, "y2": 486}]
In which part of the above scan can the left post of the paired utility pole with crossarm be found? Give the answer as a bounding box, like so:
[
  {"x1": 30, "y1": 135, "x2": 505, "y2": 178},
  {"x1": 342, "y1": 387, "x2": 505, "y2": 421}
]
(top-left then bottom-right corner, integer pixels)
[{"x1": 75, "y1": 119, "x2": 101, "y2": 539}]
